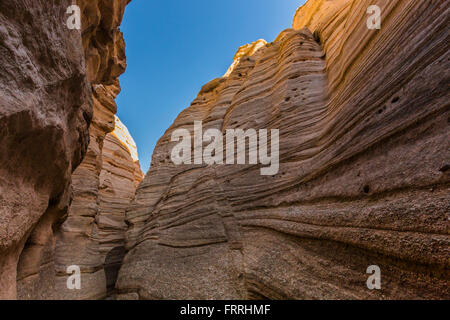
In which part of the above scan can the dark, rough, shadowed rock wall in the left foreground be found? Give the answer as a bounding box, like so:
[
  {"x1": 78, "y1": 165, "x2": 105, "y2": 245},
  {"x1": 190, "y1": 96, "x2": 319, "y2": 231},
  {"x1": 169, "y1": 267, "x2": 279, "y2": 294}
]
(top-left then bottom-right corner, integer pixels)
[{"x1": 0, "y1": 0, "x2": 92, "y2": 299}]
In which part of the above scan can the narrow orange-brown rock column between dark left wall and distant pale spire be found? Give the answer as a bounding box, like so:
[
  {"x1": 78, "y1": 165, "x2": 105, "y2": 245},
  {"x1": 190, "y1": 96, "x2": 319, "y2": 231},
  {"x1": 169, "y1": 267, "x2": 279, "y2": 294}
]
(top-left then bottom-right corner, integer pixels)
[{"x1": 30, "y1": 0, "x2": 134, "y2": 299}]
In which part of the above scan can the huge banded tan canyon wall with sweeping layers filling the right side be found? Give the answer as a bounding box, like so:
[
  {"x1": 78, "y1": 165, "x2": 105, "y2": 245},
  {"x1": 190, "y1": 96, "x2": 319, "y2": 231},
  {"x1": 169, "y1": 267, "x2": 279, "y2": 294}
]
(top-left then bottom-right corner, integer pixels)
[{"x1": 116, "y1": 0, "x2": 450, "y2": 299}]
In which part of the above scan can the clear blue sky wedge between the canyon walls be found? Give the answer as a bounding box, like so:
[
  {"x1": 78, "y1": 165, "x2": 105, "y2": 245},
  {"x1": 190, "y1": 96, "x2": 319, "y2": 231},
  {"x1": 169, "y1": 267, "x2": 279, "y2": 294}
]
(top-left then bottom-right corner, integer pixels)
[{"x1": 117, "y1": 0, "x2": 305, "y2": 172}]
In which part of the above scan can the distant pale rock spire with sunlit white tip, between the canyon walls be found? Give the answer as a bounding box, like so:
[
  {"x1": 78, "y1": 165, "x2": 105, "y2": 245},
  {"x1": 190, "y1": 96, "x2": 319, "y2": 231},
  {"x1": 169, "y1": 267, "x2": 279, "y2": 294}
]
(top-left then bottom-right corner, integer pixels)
[{"x1": 94, "y1": 118, "x2": 144, "y2": 293}]
